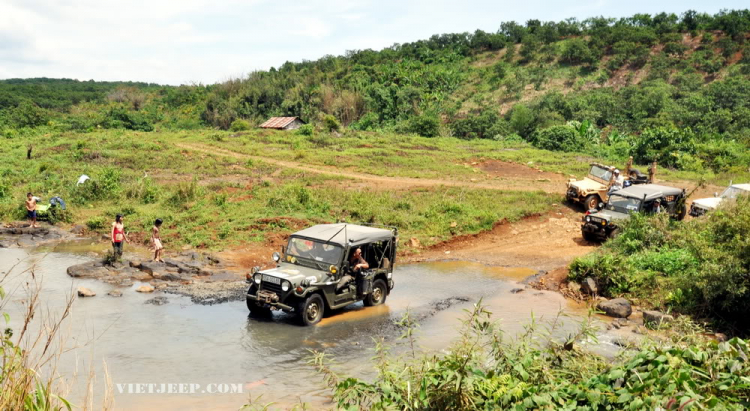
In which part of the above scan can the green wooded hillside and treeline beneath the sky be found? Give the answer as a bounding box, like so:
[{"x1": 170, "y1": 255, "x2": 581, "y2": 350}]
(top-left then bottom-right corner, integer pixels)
[{"x1": 0, "y1": 10, "x2": 750, "y2": 171}]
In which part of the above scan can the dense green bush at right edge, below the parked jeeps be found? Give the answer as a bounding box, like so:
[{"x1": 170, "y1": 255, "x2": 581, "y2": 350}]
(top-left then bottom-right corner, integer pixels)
[{"x1": 570, "y1": 196, "x2": 750, "y2": 333}]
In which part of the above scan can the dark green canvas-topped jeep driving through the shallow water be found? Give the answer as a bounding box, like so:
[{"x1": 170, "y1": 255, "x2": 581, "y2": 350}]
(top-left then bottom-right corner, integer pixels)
[{"x1": 247, "y1": 223, "x2": 398, "y2": 325}]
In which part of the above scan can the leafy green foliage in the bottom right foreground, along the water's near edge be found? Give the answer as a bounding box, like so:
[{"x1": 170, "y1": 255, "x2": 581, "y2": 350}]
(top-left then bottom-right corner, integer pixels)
[{"x1": 311, "y1": 301, "x2": 750, "y2": 410}]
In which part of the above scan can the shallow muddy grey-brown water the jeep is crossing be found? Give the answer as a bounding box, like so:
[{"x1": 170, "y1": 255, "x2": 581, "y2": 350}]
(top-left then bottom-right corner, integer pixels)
[{"x1": 0, "y1": 244, "x2": 600, "y2": 409}]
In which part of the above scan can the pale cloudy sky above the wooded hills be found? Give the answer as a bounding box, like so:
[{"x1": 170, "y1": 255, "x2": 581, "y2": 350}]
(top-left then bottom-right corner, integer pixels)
[{"x1": 0, "y1": 0, "x2": 748, "y2": 85}]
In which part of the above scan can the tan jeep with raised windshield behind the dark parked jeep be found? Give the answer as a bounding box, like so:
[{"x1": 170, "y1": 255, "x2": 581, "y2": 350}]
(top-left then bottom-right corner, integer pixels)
[{"x1": 565, "y1": 157, "x2": 656, "y2": 210}]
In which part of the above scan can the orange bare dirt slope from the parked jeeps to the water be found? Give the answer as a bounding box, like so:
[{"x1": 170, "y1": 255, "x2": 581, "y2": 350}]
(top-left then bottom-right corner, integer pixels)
[{"x1": 401, "y1": 206, "x2": 597, "y2": 271}]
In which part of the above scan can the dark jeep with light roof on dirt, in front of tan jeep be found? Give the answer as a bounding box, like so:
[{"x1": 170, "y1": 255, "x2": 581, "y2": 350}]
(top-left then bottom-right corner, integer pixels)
[{"x1": 581, "y1": 184, "x2": 687, "y2": 241}]
